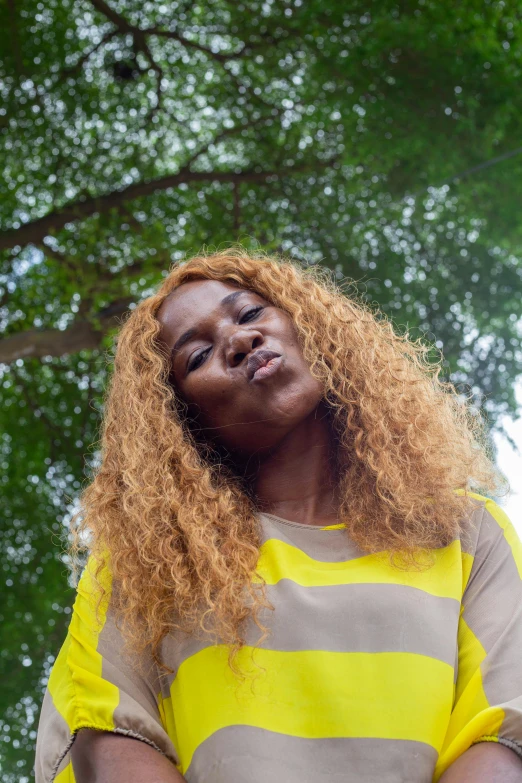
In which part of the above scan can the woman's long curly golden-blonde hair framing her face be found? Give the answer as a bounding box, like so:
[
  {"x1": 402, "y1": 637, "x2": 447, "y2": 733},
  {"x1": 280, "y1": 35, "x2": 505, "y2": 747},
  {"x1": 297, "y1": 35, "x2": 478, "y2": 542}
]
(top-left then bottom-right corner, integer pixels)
[{"x1": 72, "y1": 247, "x2": 503, "y2": 662}]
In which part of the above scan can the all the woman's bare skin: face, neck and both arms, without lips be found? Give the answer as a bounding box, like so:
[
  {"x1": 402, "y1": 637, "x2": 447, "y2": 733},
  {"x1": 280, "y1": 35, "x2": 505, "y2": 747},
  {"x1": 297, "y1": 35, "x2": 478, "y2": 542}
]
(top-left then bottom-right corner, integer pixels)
[{"x1": 72, "y1": 280, "x2": 522, "y2": 783}]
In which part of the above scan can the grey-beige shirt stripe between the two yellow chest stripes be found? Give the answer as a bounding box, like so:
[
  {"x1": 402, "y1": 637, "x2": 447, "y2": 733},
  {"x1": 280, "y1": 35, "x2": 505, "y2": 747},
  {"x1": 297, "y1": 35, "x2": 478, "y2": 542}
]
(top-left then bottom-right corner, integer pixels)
[{"x1": 163, "y1": 579, "x2": 460, "y2": 687}]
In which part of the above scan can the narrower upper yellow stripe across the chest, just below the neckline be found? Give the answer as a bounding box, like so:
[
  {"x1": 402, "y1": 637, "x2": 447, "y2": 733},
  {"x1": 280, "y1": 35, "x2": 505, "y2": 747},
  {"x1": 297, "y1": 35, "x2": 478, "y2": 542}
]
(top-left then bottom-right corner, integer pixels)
[{"x1": 254, "y1": 538, "x2": 462, "y2": 601}]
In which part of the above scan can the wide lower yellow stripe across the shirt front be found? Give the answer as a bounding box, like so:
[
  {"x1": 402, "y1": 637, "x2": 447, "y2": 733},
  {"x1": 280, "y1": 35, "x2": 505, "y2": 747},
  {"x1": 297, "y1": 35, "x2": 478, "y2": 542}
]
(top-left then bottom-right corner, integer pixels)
[{"x1": 171, "y1": 645, "x2": 453, "y2": 772}]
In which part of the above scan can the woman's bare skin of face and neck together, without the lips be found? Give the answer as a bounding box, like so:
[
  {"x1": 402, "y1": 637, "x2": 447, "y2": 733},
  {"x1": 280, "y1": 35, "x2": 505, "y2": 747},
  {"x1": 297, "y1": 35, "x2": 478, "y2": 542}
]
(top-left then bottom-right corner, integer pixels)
[{"x1": 158, "y1": 280, "x2": 337, "y2": 525}]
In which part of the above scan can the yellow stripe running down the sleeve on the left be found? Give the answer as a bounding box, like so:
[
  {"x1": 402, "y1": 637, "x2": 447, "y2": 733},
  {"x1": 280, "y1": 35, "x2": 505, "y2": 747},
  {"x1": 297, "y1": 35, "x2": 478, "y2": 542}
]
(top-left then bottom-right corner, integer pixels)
[{"x1": 49, "y1": 561, "x2": 120, "y2": 733}]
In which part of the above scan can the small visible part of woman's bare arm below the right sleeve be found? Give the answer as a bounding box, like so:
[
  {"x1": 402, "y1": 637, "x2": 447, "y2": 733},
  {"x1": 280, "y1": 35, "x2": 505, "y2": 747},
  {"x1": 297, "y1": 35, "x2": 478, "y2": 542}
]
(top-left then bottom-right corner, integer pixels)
[{"x1": 439, "y1": 742, "x2": 522, "y2": 783}]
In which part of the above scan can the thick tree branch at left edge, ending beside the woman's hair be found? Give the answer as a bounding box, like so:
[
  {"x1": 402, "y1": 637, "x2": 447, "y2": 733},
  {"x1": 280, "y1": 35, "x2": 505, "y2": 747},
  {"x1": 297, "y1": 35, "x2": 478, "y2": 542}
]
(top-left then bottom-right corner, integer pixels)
[{"x1": 0, "y1": 298, "x2": 132, "y2": 364}]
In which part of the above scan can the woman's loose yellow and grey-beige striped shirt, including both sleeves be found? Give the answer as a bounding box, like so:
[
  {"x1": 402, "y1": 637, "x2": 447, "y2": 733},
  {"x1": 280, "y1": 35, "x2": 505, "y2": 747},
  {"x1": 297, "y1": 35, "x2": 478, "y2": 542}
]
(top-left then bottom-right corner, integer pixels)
[{"x1": 36, "y1": 495, "x2": 522, "y2": 783}]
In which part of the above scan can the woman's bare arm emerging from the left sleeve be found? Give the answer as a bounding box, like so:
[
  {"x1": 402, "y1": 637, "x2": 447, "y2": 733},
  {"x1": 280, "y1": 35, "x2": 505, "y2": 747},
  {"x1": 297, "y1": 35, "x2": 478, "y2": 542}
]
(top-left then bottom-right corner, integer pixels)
[{"x1": 71, "y1": 729, "x2": 187, "y2": 783}]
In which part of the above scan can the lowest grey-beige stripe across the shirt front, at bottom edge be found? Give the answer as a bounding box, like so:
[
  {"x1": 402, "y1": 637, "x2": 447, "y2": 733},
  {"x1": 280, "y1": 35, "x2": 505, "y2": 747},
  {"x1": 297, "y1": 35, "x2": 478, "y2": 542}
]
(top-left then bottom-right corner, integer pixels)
[{"x1": 185, "y1": 726, "x2": 438, "y2": 783}]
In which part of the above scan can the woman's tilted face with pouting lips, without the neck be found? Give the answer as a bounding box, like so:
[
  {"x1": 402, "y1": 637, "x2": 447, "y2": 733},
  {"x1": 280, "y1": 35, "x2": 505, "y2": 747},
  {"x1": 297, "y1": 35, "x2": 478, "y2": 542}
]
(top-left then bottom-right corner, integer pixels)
[{"x1": 158, "y1": 280, "x2": 322, "y2": 454}]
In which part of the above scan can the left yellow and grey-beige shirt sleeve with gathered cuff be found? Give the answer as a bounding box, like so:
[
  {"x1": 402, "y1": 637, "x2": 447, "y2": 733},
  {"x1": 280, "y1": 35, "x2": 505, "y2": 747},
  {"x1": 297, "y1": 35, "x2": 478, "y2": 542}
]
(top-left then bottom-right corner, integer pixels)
[{"x1": 35, "y1": 561, "x2": 179, "y2": 783}]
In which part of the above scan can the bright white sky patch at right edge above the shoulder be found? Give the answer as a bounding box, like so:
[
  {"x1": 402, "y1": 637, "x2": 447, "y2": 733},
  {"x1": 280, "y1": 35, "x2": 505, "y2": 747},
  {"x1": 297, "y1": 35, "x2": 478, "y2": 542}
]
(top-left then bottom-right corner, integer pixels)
[{"x1": 494, "y1": 379, "x2": 522, "y2": 539}]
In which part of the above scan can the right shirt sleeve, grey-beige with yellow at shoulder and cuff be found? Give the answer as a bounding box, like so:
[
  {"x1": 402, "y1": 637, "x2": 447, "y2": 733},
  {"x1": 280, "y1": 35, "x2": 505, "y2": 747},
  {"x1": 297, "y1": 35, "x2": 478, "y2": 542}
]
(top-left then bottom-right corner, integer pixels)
[{"x1": 433, "y1": 498, "x2": 522, "y2": 782}]
